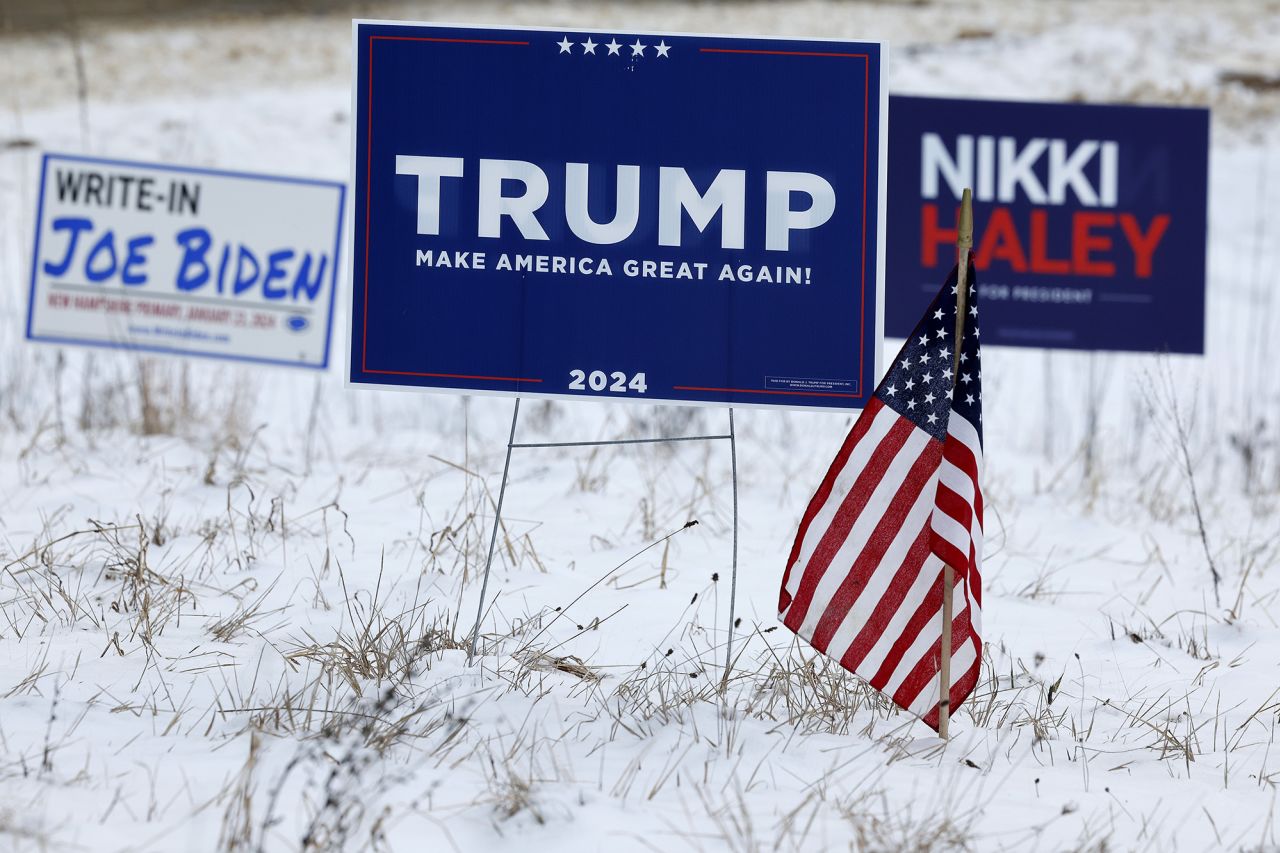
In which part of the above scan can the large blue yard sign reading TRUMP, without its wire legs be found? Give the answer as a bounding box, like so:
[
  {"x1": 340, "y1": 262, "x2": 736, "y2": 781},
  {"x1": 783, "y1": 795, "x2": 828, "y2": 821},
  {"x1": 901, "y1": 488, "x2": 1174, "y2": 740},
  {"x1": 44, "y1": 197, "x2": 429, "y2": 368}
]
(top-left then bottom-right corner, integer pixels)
[{"x1": 349, "y1": 22, "x2": 887, "y2": 410}]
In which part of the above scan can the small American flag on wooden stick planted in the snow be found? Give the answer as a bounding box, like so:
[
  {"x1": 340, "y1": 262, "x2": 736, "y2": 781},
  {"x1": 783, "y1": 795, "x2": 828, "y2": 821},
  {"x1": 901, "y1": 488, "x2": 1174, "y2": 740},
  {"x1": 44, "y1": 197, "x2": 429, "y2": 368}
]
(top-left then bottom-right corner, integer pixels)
[{"x1": 778, "y1": 266, "x2": 982, "y2": 729}]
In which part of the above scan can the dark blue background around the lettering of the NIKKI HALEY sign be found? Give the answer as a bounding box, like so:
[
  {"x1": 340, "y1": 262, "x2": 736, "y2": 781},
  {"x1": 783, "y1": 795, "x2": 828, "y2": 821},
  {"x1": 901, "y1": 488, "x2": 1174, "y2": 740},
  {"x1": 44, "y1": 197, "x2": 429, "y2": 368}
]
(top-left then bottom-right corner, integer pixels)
[{"x1": 886, "y1": 96, "x2": 1210, "y2": 353}]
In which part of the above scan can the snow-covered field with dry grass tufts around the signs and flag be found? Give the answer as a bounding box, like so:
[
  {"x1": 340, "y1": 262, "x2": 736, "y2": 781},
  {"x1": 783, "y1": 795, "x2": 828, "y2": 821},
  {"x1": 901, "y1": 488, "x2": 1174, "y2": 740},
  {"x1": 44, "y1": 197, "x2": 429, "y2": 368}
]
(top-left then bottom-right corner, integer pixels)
[{"x1": 0, "y1": 0, "x2": 1280, "y2": 853}]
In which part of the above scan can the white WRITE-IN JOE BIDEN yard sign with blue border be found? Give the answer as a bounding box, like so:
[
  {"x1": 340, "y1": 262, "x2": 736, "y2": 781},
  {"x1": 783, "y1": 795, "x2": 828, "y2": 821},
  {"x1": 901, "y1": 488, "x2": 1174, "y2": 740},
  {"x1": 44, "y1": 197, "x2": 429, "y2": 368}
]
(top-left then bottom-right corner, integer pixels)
[{"x1": 27, "y1": 154, "x2": 346, "y2": 369}]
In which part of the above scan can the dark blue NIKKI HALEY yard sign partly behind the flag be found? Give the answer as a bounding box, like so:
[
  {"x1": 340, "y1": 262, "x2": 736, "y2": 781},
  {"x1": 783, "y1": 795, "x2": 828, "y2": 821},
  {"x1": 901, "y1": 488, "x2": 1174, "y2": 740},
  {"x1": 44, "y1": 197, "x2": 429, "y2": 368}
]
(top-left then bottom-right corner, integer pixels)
[{"x1": 886, "y1": 96, "x2": 1208, "y2": 353}]
